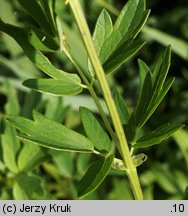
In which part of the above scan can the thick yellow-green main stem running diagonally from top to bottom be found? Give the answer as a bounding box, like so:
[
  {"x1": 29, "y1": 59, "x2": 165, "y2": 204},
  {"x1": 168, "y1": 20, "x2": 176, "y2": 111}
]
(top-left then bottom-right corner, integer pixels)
[{"x1": 68, "y1": 0, "x2": 143, "y2": 200}]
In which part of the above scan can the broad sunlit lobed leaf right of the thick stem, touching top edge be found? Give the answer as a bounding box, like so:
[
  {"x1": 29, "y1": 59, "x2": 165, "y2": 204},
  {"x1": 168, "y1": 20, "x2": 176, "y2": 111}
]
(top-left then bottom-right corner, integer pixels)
[{"x1": 94, "y1": 0, "x2": 149, "y2": 73}]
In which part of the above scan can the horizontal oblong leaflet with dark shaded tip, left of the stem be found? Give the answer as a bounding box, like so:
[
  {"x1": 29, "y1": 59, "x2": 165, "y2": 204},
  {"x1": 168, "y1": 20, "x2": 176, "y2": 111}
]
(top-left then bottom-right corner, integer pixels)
[{"x1": 23, "y1": 77, "x2": 82, "y2": 96}]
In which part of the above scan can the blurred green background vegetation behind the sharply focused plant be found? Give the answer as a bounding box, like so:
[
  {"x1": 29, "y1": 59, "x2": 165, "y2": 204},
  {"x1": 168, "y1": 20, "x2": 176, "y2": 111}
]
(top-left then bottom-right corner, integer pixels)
[{"x1": 0, "y1": 0, "x2": 188, "y2": 199}]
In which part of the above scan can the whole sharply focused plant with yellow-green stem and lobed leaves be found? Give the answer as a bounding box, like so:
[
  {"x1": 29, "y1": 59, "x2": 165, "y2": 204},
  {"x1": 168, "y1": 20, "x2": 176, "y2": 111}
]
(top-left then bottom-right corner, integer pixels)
[{"x1": 0, "y1": 0, "x2": 182, "y2": 200}]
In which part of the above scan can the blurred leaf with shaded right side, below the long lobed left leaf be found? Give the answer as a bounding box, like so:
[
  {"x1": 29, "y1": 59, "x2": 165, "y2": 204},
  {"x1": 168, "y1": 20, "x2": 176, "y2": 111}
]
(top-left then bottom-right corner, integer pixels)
[{"x1": 18, "y1": 142, "x2": 49, "y2": 172}]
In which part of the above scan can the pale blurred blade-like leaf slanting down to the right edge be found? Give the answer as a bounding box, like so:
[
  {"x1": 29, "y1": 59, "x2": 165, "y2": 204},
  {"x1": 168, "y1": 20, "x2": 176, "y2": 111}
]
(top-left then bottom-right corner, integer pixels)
[{"x1": 142, "y1": 26, "x2": 188, "y2": 60}]
